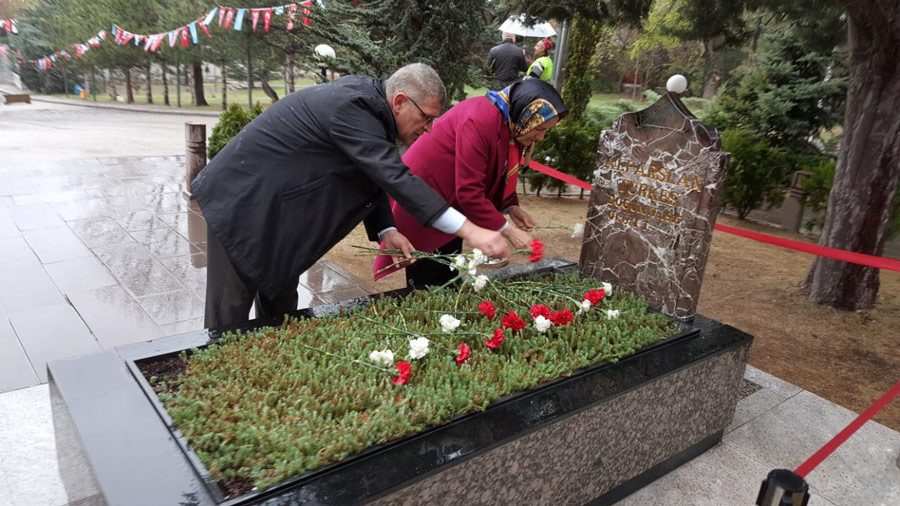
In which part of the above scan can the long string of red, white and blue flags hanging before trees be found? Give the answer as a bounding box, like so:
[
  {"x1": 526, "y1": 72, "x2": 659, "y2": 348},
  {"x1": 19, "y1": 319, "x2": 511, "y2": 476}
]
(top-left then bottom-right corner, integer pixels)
[{"x1": 19, "y1": 0, "x2": 313, "y2": 71}]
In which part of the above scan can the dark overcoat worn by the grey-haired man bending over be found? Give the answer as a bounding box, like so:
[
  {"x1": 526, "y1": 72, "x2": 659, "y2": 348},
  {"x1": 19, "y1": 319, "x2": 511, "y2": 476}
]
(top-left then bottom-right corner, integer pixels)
[{"x1": 191, "y1": 76, "x2": 448, "y2": 297}]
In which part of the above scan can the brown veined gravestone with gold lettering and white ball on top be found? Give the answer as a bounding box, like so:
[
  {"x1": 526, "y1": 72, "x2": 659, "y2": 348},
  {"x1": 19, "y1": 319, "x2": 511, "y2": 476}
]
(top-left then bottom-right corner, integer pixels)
[{"x1": 579, "y1": 76, "x2": 728, "y2": 319}]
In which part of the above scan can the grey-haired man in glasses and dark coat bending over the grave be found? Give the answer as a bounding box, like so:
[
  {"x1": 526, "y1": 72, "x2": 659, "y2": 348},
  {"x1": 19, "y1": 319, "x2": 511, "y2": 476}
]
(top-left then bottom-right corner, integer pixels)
[{"x1": 191, "y1": 64, "x2": 509, "y2": 328}]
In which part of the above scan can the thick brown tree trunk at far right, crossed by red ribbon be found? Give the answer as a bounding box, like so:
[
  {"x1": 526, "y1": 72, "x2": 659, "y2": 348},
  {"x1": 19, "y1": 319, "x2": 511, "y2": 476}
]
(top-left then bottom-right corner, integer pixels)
[{"x1": 807, "y1": 6, "x2": 900, "y2": 309}]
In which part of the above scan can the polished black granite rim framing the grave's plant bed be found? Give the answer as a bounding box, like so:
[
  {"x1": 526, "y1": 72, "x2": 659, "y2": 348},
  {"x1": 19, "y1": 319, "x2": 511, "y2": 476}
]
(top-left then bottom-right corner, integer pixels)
[{"x1": 118, "y1": 263, "x2": 750, "y2": 504}]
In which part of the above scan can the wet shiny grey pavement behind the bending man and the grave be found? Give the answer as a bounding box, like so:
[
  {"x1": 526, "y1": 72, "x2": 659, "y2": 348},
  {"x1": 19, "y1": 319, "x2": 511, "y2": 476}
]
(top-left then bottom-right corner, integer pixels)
[{"x1": 0, "y1": 104, "x2": 366, "y2": 392}]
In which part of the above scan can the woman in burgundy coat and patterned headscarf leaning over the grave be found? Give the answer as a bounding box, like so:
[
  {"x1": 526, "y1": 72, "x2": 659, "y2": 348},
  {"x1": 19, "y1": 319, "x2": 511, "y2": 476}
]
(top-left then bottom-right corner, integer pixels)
[{"x1": 375, "y1": 79, "x2": 566, "y2": 288}]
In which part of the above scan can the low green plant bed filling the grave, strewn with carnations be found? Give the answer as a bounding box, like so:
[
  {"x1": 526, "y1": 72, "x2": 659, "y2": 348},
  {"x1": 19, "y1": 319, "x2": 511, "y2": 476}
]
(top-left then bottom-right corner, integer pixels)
[{"x1": 144, "y1": 275, "x2": 679, "y2": 494}]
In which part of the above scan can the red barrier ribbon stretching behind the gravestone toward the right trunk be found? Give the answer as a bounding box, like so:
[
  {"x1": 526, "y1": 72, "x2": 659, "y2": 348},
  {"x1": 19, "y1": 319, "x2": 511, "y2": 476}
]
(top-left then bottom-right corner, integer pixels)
[{"x1": 529, "y1": 161, "x2": 900, "y2": 272}]
